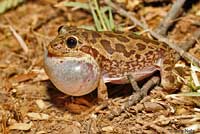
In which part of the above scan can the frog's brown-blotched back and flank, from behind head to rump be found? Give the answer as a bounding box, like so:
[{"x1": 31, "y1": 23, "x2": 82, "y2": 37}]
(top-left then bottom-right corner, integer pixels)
[{"x1": 79, "y1": 30, "x2": 171, "y2": 77}]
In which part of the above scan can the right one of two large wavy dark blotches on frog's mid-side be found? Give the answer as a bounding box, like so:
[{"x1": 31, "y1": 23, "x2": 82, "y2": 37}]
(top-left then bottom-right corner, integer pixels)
[{"x1": 115, "y1": 43, "x2": 135, "y2": 57}]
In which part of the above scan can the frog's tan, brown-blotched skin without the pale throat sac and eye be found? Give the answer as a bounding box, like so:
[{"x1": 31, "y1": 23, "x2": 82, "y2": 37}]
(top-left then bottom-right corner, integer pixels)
[{"x1": 45, "y1": 26, "x2": 180, "y2": 99}]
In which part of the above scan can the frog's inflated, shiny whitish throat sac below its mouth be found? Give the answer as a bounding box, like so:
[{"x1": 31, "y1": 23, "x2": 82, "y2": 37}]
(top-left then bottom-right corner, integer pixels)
[{"x1": 44, "y1": 49, "x2": 100, "y2": 96}]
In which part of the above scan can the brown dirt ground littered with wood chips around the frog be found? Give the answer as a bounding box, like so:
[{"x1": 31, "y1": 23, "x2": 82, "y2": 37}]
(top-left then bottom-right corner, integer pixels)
[{"x1": 0, "y1": 0, "x2": 200, "y2": 134}]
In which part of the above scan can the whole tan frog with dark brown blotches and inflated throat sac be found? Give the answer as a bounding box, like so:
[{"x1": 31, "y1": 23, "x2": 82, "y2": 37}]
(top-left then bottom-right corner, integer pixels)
[{"x1": 44, "y1": 25, "x2": 180, "y2": 100}]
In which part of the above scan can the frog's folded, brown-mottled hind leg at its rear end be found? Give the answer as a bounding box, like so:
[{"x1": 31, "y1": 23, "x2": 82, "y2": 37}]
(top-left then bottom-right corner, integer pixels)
[{"x1": 161, "y1": 52, "x2": 181, "y2": 92}]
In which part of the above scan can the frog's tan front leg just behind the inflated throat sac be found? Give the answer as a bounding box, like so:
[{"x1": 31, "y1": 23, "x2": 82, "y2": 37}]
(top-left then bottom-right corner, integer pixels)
[{"x1": 97, "y1": 78, "x2": 108, "y2": 102}]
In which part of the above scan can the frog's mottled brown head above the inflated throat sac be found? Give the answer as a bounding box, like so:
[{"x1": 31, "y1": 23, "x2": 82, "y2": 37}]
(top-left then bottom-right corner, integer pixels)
[{"x1": 48, "y1": 26, "x2": 87, "y2": 57}]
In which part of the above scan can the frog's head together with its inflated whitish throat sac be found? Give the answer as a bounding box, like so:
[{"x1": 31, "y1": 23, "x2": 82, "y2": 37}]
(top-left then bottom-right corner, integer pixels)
[{"x1": 44, "y1": 26, "x2": 100, "y2": 96}]
